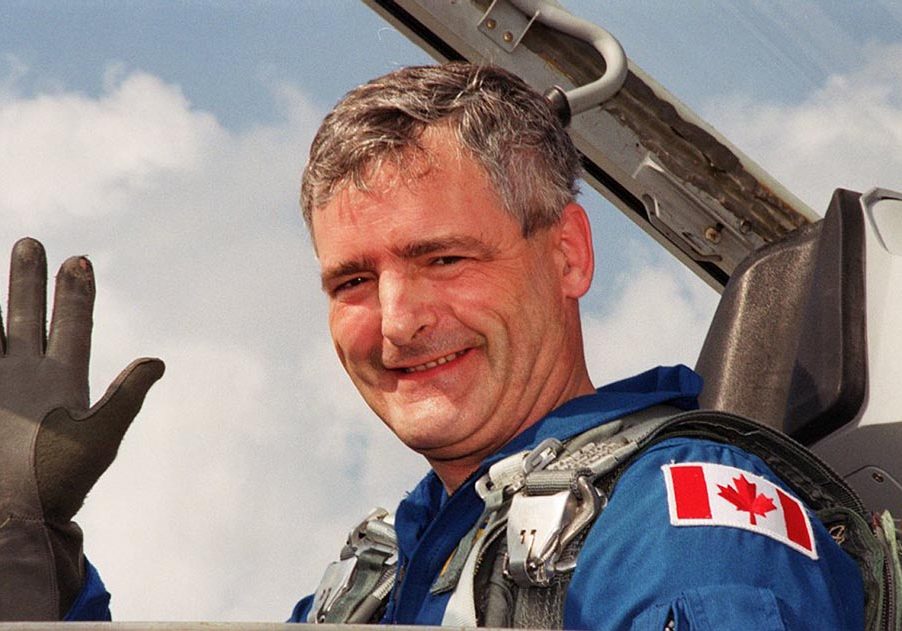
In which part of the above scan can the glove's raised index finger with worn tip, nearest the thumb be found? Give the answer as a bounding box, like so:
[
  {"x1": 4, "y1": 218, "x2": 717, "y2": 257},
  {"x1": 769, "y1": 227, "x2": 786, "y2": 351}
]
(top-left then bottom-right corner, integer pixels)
[{"x1": 47, "y1": 256, "x2": 95, "y2": 385}]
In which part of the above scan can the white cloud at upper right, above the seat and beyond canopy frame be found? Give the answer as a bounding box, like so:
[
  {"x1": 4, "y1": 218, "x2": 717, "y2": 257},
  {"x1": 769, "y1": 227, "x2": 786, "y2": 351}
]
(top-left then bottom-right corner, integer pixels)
[{"x1": 705, "y1": 44, "x2": 902, "y2": 213}]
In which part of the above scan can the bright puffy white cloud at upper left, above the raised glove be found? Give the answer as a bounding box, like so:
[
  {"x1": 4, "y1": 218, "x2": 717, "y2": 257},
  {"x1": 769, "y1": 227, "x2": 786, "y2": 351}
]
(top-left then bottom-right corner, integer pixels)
[{"x1": 0, "y1": 69, "x2": 222, "y2": 229}]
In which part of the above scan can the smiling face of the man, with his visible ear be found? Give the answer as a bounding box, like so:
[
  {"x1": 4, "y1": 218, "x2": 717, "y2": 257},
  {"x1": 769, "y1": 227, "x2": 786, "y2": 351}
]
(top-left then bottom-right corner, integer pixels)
[{"x1": 313, "y1": 131, "x2": 592, "y2": 474}]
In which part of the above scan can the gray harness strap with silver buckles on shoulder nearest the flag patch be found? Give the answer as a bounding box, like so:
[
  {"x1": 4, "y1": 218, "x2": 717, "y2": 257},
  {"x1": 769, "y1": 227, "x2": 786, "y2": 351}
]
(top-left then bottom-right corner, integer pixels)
[{"x1": 442, "y1": 406, "x2": 676, "y2": 629}]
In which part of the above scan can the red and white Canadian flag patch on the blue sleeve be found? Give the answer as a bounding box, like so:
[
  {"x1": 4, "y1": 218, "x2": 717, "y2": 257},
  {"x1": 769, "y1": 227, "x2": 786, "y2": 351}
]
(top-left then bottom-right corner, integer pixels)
[{"x1": 662, "y1": 462, "x2": 817, "y2": 559}]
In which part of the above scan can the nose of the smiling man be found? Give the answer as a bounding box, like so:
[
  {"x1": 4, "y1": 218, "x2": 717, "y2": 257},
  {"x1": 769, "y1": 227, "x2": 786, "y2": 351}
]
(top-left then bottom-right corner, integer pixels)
[{"x1": 379, "y1": 272, "x2": 436, "y2": 346}]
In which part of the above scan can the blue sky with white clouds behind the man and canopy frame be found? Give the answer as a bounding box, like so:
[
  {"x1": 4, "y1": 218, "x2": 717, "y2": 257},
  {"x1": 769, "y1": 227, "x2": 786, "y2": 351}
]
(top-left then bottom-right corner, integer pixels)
[{"x1": 0, "y1": 0, "x2": 902, "y2": 621}]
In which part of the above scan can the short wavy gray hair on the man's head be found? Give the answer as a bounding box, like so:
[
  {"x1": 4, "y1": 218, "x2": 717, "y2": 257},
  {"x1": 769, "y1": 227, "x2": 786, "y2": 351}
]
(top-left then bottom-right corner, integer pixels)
[{"x1": 301, "y1": 62, "x2": 580, "y2": 236}]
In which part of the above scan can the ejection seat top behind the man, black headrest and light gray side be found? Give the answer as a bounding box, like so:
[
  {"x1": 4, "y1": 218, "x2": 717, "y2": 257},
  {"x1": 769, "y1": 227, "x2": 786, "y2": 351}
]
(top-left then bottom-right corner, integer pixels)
[{"x1": 696, "y1": 189, "x2": 902, "y2": 515}]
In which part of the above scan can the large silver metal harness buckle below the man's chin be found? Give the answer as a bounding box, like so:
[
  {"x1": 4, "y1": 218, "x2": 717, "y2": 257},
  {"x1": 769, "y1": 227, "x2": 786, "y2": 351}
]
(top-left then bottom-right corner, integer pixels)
[{"x1": 507, "y1": 477, "x2": 600, "y2": 587}]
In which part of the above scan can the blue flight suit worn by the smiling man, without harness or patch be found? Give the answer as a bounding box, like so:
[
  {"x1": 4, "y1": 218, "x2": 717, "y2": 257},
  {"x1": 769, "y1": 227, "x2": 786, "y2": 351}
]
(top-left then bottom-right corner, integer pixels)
[{"x1": 67, "y1": 366, "x2": 864, "y2": 631}]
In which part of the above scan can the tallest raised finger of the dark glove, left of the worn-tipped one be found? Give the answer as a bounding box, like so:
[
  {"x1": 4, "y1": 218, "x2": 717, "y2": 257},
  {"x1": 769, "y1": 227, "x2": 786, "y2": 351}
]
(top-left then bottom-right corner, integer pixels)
[{"x1": 6, "y1": 237, "x2": 47, "y2": 356}]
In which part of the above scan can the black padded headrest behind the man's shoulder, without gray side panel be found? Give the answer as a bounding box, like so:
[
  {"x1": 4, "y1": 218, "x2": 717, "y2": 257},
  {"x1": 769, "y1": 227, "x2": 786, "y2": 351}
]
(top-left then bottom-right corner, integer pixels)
[{"x1": 696, "y1": 189, "x2": 867, "y2": 444}]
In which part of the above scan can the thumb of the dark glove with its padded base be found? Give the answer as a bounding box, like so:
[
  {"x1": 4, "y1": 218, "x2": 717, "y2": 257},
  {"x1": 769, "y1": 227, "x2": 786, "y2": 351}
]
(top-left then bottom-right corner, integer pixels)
[{"x1": 35, "y1": 358, "x2": 164, "y2": 520}]
